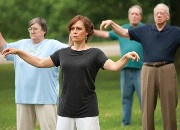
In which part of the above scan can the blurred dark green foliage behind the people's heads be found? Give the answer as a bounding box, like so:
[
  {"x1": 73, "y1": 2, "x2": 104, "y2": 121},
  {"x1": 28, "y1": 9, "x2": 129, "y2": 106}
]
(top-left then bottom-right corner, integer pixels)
[{"x1": 0, "y1": 0, "x2": 164, "y2": 42}]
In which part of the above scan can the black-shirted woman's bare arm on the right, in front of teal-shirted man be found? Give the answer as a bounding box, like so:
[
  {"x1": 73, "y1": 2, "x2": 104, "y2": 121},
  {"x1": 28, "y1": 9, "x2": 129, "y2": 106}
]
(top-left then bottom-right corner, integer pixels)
[{"x1": 103, "y1": 51, "x2": 140, "y2": 71}]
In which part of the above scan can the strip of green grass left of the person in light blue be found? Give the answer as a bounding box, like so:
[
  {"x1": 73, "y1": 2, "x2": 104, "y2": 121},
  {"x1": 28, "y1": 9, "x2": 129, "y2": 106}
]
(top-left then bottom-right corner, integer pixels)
[{"x1": 0, "y1": 64, "x2": 16, "y2": 130}]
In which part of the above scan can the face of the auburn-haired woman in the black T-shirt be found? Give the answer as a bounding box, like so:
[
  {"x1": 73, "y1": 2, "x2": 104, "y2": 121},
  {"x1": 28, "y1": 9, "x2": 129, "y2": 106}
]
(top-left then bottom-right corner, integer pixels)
[{"x1": 70, "y1": 20, "x2": 88, "y2": 43}]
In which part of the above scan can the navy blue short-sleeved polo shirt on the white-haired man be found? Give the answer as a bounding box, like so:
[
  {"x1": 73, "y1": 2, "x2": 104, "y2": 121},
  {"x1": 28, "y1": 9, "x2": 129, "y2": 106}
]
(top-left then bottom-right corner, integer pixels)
[{"x1": 128, "y1": 24, "x2": 180, "y2": 62}]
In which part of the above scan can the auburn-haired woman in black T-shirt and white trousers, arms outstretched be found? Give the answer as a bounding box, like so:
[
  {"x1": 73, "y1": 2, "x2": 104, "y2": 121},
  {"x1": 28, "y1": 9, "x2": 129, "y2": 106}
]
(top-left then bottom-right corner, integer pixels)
[{"x1": 2, "y1": 15, "x2": 139, "y2": 130}]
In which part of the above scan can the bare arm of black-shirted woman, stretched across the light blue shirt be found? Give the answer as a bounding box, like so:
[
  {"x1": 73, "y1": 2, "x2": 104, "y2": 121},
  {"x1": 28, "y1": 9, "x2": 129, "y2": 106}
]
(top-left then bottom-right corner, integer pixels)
[{"x1": 2, "y1": 48, "x2": 54, "y2": 68}]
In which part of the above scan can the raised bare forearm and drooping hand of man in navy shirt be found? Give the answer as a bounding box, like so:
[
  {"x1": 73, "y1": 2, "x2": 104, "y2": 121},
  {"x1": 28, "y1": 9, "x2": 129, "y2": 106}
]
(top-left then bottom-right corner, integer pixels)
[{"x1": 100, "y1": 20, "x2": 129, "y2": 38}]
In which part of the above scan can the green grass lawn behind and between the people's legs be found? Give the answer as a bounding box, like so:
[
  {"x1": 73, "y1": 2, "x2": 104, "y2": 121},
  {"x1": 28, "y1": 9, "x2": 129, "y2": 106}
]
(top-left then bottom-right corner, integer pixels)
[{"x1": 0, "y1": 62, "x2": 180, "y2": 130}]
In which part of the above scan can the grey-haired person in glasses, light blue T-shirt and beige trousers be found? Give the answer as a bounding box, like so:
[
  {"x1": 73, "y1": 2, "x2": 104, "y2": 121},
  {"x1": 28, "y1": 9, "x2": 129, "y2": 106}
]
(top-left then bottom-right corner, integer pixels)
[{"x1": 0, "y1": 18, "x2": 67, "y2": 130}]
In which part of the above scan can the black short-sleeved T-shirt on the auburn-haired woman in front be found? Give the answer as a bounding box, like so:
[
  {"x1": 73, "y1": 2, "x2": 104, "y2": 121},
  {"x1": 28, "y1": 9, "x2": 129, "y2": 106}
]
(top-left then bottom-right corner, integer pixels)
[{"x1": 50, "y1": 47, "x2": 108, "y2": 118}]
